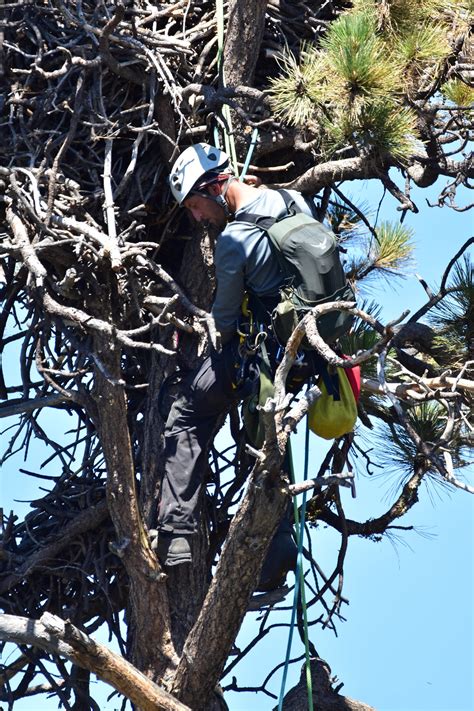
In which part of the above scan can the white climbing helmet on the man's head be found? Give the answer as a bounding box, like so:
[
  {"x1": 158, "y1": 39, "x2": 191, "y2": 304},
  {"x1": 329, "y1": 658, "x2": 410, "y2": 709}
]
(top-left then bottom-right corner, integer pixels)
[{"x1": 169, "y1": 143, "x2": 229, "y2": 205}]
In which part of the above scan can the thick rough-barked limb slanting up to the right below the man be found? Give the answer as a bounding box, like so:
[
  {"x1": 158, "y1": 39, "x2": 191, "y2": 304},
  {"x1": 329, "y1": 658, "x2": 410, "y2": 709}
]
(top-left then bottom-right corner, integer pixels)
[{"x1": 172, "y1": 452, "x2": 288, "y2": 709}]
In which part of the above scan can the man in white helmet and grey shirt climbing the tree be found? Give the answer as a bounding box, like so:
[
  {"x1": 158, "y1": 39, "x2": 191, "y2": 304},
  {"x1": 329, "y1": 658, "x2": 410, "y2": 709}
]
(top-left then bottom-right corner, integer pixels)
[{"x1": 157, "y1": 143, "x2": 352, "y2": 579}]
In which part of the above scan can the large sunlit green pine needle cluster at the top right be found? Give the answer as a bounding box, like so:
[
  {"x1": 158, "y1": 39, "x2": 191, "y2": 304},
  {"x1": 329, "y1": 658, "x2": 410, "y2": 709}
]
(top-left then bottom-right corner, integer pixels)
[{"x1": 269, "y1": 0, "x2": 471, "y2": 164}]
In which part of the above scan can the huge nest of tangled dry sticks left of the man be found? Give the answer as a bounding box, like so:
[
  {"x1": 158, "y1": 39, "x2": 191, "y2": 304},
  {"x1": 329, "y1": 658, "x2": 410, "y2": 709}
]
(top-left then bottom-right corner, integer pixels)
[{"x1": 0, "y1": 0, "x2": 348, "y2": 632}]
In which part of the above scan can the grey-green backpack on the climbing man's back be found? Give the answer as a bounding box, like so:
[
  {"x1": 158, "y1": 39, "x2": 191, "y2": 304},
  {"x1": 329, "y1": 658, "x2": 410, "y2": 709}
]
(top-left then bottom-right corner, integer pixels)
[{"x1": 236, "y1": 190, "x2": 355, "y2": 346}]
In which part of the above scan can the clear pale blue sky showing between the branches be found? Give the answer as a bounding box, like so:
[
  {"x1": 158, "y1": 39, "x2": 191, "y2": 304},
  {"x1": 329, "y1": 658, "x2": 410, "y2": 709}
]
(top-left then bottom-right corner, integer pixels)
[{"x1": 0, "y1": 174, "x2": 474, "y2": 711}]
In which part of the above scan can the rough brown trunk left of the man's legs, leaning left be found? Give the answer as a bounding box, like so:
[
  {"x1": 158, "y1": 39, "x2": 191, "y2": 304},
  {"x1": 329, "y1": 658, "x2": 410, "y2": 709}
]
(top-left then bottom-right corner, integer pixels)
[{"x1": 95, "y1": 342, "x2": 176, "y2": 679}]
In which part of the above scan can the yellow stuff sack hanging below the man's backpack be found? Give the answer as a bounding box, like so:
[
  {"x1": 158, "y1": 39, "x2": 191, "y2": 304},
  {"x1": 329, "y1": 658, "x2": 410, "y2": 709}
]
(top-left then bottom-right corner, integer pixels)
[{"x1": 308, "y1": 368, "x2": 357, "y2": 439}]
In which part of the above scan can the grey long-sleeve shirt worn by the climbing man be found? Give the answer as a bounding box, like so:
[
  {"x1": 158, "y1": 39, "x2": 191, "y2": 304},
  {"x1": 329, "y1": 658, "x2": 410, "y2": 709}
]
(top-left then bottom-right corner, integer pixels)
[{"x1": 212, "y1": 190, "x2": 311, "y2": 341}]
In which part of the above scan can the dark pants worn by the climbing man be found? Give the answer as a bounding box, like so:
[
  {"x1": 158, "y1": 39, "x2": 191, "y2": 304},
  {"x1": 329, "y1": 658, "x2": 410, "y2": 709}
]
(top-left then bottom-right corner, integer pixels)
[{"x1": 158, "y1": 339, "x2": 248, "y2": 534}]
